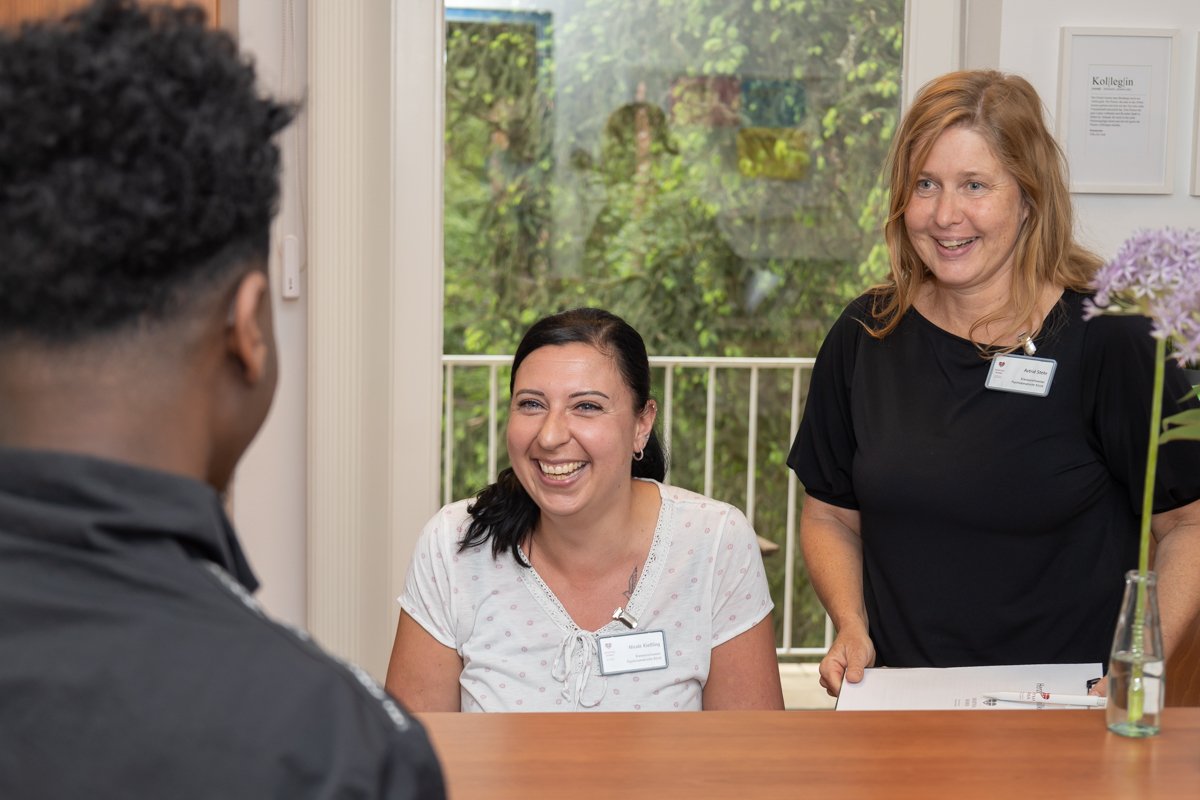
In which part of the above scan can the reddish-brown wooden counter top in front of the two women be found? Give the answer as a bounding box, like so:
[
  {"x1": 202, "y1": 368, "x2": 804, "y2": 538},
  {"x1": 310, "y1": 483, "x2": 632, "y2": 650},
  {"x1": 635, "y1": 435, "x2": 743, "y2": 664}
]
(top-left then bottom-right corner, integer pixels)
[{"x1": 418, "y1": 708, "x2": 1200, "y2": 800}]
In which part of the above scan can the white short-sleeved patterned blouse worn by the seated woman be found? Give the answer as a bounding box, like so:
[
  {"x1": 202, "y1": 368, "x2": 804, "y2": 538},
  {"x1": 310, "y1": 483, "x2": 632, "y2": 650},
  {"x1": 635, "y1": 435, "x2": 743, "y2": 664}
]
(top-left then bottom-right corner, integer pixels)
[{"x1": 400, "y1": 483, "x2": 773, "y2": 711}]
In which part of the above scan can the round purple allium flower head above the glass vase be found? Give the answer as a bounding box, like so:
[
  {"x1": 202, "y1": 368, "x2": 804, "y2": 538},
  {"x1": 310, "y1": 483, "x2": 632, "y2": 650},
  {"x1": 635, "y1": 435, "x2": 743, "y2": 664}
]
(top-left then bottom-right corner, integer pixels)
[{"x1": 1084, "y1": 228, "x2": 1200, "y2": 365}]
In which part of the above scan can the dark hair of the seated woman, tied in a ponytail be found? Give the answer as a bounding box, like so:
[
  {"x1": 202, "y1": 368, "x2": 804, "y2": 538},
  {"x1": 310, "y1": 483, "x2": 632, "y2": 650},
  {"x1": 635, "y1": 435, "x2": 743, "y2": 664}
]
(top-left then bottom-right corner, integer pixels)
[{"x1": 458, "y1": 308, "x2": 667, "y2": 566}]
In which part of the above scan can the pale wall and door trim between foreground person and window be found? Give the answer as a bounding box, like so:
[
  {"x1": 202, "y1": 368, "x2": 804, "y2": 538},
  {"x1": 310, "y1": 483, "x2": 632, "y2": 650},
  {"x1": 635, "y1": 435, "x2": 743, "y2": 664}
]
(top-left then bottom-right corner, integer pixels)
[{"x1": 225, "y1": 0, "x2": 443, "y2": 678}]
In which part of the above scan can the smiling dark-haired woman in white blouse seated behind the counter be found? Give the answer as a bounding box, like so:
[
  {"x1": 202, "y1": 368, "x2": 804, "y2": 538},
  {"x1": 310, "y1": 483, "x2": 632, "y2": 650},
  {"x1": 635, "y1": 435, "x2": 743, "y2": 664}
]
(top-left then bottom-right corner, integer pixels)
[{"x1": 388, "y1": 308, "x2": 782, "y2": 711}]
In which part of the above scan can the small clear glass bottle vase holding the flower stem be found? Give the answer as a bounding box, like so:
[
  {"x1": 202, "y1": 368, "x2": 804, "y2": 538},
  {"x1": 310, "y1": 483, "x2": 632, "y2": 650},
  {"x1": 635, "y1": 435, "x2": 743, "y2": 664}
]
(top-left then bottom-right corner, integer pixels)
[{"x1": 1105, "y1": 570, "x2": 1164, "y2": 738}]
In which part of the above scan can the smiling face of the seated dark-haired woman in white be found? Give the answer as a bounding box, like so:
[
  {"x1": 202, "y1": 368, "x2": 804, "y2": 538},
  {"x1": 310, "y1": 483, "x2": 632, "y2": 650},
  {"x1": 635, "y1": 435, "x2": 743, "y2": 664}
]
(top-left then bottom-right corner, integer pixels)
[{"x1": 508, "y1": 343, "x2": 655, "y2": 518}]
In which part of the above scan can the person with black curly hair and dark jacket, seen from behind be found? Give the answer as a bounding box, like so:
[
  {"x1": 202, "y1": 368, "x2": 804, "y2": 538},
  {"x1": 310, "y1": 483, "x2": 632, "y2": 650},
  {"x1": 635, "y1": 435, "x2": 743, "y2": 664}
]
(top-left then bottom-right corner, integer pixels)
[{"x1": 0, "y1": 0, "x2": 444, "y2": 800}]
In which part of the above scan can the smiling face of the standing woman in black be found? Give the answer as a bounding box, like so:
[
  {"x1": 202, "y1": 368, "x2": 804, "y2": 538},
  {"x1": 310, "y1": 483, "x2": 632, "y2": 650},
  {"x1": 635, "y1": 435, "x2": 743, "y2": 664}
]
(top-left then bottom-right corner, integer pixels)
[{"x1": 904, "y1": 127, "x2": 1028, "y2": 295}]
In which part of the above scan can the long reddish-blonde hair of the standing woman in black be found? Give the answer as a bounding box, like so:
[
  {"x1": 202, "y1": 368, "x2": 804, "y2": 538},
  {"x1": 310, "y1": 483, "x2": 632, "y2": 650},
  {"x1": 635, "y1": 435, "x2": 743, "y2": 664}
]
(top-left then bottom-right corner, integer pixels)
[{"x1": 868, "y1": 70, "x2": 1103, "y2": 349}]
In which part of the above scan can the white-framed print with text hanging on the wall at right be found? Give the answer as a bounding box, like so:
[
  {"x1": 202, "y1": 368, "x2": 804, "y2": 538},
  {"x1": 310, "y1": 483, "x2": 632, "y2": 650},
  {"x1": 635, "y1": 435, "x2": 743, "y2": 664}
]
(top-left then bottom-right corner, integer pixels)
[{"x1": 1057, "y1": 28, "x2": 1180, "y2": 194}]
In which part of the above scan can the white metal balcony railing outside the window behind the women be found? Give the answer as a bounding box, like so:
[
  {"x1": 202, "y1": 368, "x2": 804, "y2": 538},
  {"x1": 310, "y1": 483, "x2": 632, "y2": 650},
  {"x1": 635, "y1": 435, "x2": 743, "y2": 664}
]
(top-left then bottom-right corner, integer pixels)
[{"x1": 442, "y1": 355, "x2": 833, "y2": 657}]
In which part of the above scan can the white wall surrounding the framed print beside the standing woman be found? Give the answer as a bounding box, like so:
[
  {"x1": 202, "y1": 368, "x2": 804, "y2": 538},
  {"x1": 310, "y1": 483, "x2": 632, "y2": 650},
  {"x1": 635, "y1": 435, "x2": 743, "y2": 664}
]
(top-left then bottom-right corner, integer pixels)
[{"x1": 997, "y1": 0, "x2": 1200, "y2": 258}]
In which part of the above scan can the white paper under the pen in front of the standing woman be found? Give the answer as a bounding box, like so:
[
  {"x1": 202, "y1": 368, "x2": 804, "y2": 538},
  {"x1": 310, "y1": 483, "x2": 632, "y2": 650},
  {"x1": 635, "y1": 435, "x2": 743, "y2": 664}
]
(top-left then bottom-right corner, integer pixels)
[{"x1": 836, "y1": 663, "x2": 1103, "y2": 711}]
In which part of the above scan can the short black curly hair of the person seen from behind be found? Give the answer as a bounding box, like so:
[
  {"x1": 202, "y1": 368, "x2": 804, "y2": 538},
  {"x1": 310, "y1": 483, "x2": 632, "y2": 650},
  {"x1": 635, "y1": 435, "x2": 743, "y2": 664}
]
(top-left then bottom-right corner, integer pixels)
[{"x1": 0, "y1": 0, "x2": 295, "y2": 343}]
